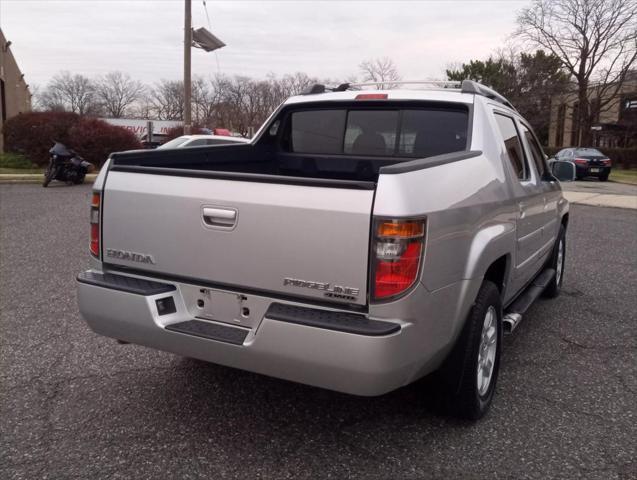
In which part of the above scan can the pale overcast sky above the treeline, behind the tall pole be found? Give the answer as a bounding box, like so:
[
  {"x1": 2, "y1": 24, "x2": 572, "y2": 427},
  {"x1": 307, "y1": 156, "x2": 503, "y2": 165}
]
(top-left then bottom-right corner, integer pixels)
[{"x1": 0, "y1": 0, "x2": 529, "y2": 85}]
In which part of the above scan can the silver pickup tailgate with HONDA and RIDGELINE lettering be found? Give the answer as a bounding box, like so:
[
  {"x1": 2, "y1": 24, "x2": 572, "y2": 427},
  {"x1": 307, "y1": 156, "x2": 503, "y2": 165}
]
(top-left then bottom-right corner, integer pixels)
[{"x1": 102, "y1": 171, "x2": 374, "y2": 305}]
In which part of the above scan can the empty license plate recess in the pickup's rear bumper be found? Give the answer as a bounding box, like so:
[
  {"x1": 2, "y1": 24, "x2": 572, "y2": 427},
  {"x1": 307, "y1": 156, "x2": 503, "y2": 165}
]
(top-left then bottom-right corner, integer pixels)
[{"x1": 181, "y1": 286, "x2": 270, "y2": 328}]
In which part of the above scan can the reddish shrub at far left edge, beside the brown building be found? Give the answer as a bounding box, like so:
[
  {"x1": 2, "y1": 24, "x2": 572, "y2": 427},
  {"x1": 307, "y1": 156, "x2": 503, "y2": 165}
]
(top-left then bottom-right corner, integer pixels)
[{"x1": 2, "y1": 112, "x2": 80, "y2": 165}]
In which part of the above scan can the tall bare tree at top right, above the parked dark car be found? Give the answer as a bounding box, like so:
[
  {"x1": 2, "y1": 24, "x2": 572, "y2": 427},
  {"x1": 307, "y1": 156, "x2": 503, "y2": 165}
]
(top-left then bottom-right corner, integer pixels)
[{"x1": 517, "y1": 0, "x2": 637, "y2": 145}]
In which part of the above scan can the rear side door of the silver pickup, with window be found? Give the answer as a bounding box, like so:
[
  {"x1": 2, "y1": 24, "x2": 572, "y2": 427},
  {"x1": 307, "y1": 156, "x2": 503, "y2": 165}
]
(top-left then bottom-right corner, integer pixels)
[{"x1": 494, "y1": 111, "x2": 544, "y2": 293}]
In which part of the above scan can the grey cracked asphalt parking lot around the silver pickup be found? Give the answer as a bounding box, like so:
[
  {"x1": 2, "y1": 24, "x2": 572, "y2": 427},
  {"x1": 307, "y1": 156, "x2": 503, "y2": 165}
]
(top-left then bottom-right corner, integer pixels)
[{"x1": 0, "y1": 185, "x2": 637, "y2": 480}]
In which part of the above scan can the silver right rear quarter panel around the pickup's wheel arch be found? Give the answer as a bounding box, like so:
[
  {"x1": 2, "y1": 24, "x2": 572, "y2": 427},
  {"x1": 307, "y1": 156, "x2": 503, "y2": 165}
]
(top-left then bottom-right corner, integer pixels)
[{"x1": 370, "y1": 101, "x2": 518, "y2": 377}]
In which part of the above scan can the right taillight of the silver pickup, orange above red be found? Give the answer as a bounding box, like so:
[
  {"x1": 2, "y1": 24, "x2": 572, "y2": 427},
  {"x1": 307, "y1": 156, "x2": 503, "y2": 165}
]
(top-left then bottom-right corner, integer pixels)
[{"x1": 371, "y1": 219, "x2": 426, "y2": 300}]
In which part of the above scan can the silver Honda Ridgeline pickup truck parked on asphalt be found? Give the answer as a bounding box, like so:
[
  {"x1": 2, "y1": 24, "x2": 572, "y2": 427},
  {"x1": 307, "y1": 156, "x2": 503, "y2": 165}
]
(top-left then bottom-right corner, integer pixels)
[{"x1": 77, "y1": 81, "x2": 572, "y2": 419}]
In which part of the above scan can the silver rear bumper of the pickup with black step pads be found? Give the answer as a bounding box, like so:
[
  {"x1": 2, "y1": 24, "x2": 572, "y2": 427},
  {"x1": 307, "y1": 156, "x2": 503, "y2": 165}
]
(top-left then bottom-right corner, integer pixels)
[{"x1": 78, "y1": 271, "x2": 422, "y2": 396}]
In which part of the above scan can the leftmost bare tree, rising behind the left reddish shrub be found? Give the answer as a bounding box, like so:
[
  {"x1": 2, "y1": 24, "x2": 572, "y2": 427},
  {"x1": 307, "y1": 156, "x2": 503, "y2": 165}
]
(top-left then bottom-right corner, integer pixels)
[{"x1": 39, "y1": 72, "x2": 99, "y2": 115}]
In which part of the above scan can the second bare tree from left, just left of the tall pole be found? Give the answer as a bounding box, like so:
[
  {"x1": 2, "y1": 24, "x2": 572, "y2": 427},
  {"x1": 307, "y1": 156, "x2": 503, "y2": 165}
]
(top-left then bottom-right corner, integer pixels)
[{"x1": 95, "y1": 72, "x2": 144, "y2": 118}]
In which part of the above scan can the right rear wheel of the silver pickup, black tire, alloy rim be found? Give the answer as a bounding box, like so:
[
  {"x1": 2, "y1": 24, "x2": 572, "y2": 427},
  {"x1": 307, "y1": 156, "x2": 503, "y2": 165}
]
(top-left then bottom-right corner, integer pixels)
[{"x1": 441, "y1": 280, "x2": 502, "y2": 420}]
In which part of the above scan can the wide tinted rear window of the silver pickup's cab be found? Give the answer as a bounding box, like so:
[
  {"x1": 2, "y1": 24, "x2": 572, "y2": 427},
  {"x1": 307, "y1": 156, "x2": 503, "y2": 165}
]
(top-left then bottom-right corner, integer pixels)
[{"x1": 289, "y1": 107, "x2": 469, "y2": 158}]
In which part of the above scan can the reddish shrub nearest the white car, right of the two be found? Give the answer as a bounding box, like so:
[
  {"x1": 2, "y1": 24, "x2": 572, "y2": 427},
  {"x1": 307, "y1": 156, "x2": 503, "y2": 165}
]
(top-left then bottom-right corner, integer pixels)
[{"x1": 68, "y1": 118, "x2": 142, "y2": 167}]
